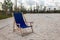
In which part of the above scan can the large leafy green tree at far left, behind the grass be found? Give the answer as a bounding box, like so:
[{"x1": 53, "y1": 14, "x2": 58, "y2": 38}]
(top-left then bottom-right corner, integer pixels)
[{"x1": 2, "y1": 0, "x2": 13, "y2": 15}]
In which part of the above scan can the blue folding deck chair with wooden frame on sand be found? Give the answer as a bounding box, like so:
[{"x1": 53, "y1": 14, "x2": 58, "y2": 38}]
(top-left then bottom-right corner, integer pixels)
[{"x1": 13, "y1": 12, "x2": 33, "y2": 35}]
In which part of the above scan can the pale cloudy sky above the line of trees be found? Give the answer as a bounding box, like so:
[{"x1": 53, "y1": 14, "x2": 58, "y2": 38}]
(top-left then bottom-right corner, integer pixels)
[{"x1": 0, "y1": 0, "x2": 60, "y2": 8}]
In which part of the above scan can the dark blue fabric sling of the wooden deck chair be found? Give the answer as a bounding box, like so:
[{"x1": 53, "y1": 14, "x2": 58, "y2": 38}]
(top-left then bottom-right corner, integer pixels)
[{"x1": 14, "y1": 12, "x2": 27, "y2": 28}]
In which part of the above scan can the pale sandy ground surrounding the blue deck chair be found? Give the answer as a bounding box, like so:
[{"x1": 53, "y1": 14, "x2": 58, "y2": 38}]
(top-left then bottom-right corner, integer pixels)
[{"x1": 0, "y1": 13, "x2": 60, "y2": 40}]
